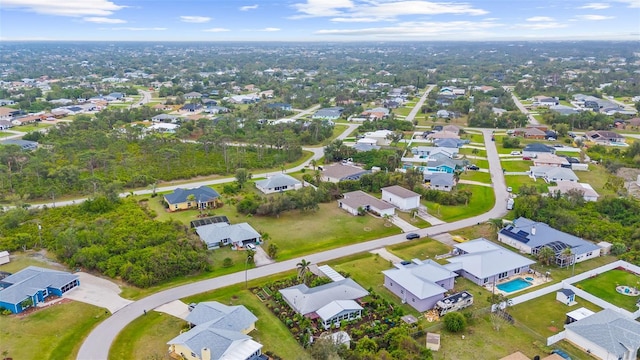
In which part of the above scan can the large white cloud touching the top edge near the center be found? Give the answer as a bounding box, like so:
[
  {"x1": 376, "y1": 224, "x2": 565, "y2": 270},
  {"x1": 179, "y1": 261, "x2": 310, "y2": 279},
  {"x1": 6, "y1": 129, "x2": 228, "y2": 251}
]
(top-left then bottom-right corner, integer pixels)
[{"x1": 291, "y1": 0, "x2": 488, "y2": 22}]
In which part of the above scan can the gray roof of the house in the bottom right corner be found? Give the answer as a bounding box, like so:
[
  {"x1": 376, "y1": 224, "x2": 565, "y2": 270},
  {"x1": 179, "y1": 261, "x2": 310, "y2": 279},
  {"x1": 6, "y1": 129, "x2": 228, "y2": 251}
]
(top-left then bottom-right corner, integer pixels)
[{"x1": 565, "y1": 309, "x2": 640, "y2": 358}]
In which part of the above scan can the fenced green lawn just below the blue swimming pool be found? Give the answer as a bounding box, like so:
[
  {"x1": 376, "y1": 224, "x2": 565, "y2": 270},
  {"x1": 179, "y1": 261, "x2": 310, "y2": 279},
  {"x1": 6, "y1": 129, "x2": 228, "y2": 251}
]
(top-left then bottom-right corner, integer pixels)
[{"x1": 509, "y1": 291, "x2": 602, "y2": 337}]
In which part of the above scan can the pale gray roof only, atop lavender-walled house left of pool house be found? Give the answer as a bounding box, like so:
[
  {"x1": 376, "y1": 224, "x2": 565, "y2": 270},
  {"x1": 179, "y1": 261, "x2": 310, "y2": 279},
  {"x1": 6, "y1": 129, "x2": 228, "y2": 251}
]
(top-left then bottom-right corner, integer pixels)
[{"x1": 382, "y1": 260, "x2": 457, "y2": 300}]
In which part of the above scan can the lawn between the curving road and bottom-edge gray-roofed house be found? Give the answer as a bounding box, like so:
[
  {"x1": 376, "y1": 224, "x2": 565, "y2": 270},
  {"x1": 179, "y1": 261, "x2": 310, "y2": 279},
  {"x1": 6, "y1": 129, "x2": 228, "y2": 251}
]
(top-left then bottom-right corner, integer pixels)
[{"x1": 109, "y1": 311, "x2": 181, "y2": 360}]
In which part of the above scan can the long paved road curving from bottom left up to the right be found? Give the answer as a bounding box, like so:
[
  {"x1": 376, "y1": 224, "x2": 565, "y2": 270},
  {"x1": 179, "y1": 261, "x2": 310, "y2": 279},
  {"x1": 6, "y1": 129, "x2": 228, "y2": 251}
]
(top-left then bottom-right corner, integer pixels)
[{"x1": 77, "y1": 130, "x2": 508, "y2": 360}]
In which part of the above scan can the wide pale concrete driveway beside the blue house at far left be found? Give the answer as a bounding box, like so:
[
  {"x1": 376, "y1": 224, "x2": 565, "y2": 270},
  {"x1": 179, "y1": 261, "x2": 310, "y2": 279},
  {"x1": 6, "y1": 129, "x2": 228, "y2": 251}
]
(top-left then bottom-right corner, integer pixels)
[{"x1": 63, "y1": 272, "x2": 133, "y2": 314}]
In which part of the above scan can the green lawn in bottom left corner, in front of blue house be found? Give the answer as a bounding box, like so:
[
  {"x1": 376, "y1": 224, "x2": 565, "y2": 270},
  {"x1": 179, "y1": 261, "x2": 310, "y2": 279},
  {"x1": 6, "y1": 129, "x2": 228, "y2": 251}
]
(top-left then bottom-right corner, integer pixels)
[{"x1": 0, "y1": 300, "x2": 108, "y2": 360}]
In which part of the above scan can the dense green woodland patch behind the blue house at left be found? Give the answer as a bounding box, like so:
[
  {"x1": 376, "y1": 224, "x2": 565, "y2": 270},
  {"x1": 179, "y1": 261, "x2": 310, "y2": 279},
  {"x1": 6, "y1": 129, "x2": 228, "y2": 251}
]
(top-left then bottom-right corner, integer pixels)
[{"x1": 0, "y1": 196, "x2": 210, "y2": 287}]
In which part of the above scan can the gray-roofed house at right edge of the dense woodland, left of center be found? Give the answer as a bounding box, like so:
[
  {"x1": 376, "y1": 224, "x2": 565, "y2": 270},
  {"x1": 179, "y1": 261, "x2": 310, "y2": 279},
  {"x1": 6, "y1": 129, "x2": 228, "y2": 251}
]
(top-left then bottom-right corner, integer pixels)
[{"x1": 196, "y1": 222, "x2": 261, "y2": 249}]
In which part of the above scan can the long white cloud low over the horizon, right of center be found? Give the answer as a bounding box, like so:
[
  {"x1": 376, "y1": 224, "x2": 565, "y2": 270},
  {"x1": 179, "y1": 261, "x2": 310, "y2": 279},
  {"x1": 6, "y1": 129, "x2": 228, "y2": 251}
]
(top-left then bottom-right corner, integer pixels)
[{"x1": 315, "y1": 21, "x2": 503, "y2": 39}]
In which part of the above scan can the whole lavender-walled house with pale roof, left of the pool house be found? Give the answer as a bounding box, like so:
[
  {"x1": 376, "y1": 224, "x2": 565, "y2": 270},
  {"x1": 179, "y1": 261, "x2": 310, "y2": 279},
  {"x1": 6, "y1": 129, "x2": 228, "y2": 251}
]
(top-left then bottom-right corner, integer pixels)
[{"x1": 382, "y1": 259, "x2": 457, "y2": 312}]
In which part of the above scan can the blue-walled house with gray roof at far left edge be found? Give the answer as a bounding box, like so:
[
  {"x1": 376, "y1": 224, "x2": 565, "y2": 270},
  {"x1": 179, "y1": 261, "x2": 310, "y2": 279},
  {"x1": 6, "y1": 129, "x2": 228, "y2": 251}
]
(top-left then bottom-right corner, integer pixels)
[{"x1": 0, "y1": 266, "x2": 80, "y2": 314}]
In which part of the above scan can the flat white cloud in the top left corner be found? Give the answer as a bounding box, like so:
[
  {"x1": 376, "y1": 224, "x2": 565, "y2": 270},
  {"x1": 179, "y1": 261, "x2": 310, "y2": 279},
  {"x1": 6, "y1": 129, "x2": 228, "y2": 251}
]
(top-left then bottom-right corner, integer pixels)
[{"x1": 2, "y1": 0, "x2": 126, "y2": 16}]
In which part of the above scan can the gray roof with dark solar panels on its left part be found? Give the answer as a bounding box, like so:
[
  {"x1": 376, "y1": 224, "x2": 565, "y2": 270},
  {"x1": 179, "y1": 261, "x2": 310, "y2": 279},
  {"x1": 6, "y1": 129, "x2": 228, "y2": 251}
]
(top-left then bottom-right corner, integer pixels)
[{"x1": 500, "y1": 217, "x2": 600, "y2": 255}]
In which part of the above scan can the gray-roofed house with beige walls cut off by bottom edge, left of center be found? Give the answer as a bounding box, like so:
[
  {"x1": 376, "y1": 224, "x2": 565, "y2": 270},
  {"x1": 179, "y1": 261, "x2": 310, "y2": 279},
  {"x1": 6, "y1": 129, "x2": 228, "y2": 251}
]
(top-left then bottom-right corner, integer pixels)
[{"x1": 167, "y1": 301, "x2": 262, "y2": 360}]
